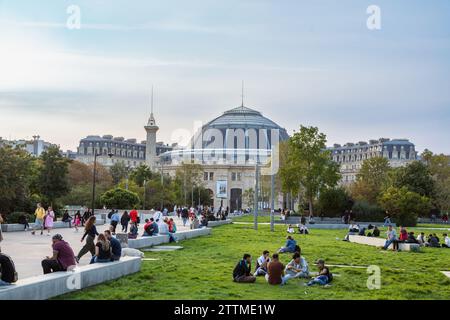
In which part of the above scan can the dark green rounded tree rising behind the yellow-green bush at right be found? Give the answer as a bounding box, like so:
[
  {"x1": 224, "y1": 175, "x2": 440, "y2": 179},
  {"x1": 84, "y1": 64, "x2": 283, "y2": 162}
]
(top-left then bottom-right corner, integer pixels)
[{"x1": 393, "y1": 161, "x2": 435, "y2": 197}]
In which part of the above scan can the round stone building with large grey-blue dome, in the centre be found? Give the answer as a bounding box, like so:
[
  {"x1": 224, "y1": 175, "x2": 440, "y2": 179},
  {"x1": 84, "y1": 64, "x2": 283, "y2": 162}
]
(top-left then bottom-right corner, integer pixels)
[{"x1": 158, "y1": 105, "x2": 289, "y2": 212}]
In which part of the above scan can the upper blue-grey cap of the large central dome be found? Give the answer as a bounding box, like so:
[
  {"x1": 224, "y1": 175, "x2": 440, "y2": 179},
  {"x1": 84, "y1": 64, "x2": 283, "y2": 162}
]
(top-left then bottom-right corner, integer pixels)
[{"x1": 203, "y1": 106, "x2": 288, "y2": 136}]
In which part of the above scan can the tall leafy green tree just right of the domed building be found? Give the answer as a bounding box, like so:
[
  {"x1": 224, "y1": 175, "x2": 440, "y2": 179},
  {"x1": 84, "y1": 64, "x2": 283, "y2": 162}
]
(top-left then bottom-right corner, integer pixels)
[{"x1": 280, "y1": 126, "x2": 340, "y2": 215}]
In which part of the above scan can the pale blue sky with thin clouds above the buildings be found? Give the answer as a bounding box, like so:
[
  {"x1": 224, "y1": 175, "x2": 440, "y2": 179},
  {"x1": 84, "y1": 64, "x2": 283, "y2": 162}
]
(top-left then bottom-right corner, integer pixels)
[{"x1": 0, "y1": 0, "x2": 450, "y2": 154}]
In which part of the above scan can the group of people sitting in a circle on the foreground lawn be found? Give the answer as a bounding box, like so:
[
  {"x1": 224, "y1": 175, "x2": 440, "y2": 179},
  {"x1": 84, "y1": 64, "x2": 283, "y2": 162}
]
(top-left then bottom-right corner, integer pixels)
[{"x1": 233, "y1": 246, "x2": 333, "y2": 286}]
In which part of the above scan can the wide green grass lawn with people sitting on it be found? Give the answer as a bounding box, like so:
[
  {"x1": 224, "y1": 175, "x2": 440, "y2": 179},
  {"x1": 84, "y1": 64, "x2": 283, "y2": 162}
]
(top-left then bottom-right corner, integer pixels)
[{"x1": 59, "y1": 224, "x2": 450, "y2": 300}]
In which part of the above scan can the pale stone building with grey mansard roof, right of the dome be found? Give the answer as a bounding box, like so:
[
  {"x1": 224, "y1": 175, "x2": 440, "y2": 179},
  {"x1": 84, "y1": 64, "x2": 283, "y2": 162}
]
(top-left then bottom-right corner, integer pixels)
[{"x1": 328, "y1": 138, "x2": 417, "y2": 185}]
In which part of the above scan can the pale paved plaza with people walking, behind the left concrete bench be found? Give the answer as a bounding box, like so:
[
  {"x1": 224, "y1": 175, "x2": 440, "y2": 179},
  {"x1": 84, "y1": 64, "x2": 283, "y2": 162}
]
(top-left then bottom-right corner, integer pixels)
[{"x1": 1, "y1": 217, "x2": 189, "y2": 279}]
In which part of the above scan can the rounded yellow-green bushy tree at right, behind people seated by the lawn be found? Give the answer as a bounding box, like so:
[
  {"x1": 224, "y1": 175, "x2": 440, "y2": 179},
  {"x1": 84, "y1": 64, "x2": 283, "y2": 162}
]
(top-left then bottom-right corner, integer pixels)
[{"x1": 379, "y1": 187, "x2": 430, "y2": 227}]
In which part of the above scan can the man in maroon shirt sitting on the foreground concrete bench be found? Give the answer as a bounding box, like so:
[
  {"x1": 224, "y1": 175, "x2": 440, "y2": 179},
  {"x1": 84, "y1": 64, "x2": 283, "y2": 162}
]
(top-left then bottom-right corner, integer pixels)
[{"x1": 41, "y1": 234, "x2": 76, "y2": 274}]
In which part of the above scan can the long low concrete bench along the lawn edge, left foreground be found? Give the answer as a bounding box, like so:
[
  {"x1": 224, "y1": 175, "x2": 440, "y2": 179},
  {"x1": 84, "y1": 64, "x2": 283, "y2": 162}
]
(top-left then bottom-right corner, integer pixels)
[{"x1": 0, "y1": 257, "x2": 141, "y2": 300}]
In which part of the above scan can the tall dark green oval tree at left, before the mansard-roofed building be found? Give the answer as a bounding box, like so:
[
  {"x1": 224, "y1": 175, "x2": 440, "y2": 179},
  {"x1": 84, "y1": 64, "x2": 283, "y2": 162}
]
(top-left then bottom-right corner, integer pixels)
[{"x1": 38, "y1": 146, "x2": 70, "y2": 205}]
